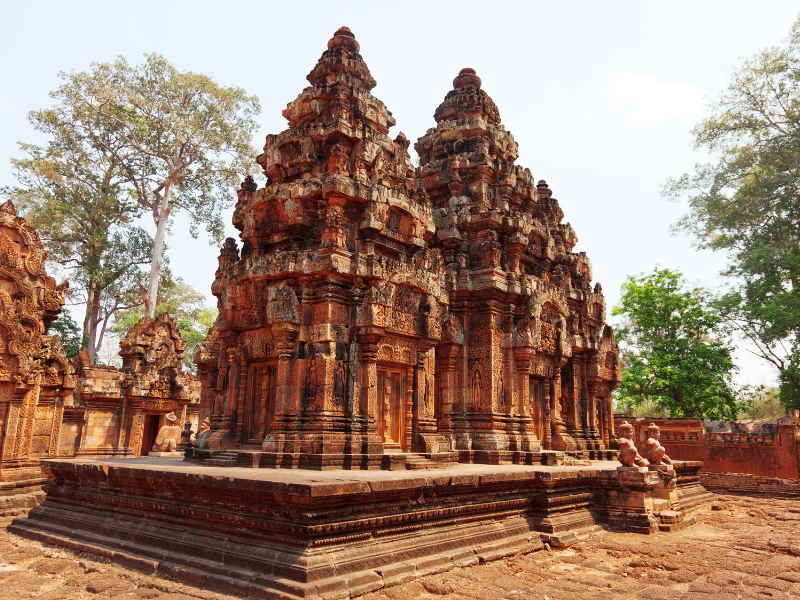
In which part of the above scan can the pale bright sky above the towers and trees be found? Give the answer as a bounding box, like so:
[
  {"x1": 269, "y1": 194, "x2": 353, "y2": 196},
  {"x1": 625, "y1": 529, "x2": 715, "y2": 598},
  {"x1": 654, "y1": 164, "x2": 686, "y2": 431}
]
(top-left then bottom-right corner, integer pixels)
[{"x1": 0, "y1": 0, "x2": 798, "y2": 384}]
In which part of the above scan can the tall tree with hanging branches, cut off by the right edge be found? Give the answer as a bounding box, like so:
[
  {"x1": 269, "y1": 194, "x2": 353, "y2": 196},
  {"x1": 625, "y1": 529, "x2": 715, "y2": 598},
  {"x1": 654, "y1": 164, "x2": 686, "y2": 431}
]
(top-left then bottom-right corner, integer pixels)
[{"x1": 664, "y1": 18, "x2": 800, "y2": 407}]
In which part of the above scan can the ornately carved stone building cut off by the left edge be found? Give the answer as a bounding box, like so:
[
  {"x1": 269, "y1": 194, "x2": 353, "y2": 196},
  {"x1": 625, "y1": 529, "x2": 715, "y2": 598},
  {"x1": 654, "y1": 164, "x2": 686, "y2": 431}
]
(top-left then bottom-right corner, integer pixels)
[{"x1": 0, "y1": 200, "x2": 75, "y2": 514}]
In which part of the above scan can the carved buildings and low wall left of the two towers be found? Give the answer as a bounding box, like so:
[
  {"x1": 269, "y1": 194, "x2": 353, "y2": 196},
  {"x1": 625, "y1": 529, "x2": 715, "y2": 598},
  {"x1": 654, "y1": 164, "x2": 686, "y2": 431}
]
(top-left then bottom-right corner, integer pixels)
[{"x1": 0, "y1": 201, "x2": 199, "y2": 514}]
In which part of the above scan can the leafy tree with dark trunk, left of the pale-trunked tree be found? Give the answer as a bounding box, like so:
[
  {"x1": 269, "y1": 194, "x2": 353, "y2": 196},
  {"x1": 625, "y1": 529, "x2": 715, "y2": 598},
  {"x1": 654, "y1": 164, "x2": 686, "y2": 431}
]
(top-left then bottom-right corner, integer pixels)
[{"x1": 3, "y1": 106, "x2": 152, "y2": 360}]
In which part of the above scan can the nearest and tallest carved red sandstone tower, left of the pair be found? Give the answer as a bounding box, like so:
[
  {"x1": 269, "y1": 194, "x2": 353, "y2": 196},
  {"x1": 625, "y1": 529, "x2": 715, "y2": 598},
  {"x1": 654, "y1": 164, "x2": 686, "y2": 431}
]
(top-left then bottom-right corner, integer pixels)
[{"x1": 196, "y1": 27, "x2": 451, "y2": 468}]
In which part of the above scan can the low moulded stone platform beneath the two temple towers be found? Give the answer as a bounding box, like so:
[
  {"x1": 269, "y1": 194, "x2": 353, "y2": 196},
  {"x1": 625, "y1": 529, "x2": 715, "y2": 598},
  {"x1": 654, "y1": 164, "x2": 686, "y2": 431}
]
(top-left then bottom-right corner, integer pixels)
[{"x1": 9, "y1": 458, "x2": 704, "y2": 599}]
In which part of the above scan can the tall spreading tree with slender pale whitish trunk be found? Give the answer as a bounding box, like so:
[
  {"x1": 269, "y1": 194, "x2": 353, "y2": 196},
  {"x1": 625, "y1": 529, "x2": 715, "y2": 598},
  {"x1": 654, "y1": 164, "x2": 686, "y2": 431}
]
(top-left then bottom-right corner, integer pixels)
[{"x1": 54, "y1": 54, "x2": 260, "y2": 317}]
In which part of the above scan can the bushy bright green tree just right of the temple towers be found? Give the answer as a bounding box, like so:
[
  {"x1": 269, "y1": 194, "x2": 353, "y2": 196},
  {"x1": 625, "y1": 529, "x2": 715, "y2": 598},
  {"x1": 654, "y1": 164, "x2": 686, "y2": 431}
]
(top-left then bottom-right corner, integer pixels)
[{"x1": 612, "y1": 267, "x2": 738, "y2": 419}]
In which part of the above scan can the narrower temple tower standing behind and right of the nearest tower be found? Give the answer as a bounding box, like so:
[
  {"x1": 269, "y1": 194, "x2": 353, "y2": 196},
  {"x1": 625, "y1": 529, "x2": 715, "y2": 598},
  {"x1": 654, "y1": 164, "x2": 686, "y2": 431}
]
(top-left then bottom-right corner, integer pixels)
[{"x1": 415, "y1": 69, "x2": 620, "y2": 463}]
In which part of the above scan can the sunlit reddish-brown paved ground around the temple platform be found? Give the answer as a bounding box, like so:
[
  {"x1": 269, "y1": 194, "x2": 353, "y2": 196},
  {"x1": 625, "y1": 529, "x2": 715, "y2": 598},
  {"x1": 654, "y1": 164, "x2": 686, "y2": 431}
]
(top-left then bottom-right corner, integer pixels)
[{"x1": 0, "y1": 496, "x2": 800, "y2": 600}]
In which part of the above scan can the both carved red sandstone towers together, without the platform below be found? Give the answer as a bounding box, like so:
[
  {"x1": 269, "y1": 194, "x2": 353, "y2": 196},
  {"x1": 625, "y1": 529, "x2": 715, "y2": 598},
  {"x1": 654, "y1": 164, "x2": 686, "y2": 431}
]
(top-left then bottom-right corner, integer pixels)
[{"x1": 196, "y1": 27, "x2": 620, "y2": 469}]
